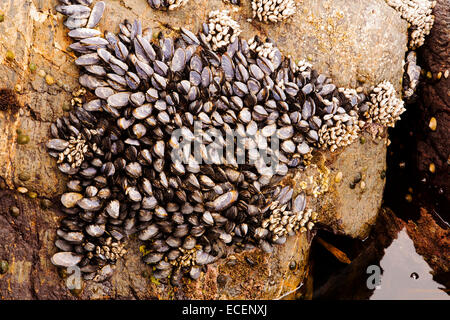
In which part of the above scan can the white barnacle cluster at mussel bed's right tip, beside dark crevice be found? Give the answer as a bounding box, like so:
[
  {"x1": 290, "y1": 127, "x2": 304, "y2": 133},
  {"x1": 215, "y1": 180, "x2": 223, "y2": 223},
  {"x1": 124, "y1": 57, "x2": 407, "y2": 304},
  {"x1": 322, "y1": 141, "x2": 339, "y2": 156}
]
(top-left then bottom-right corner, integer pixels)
[{"x1": 364, "y1": 80, "x2": 406, "y2": 127}]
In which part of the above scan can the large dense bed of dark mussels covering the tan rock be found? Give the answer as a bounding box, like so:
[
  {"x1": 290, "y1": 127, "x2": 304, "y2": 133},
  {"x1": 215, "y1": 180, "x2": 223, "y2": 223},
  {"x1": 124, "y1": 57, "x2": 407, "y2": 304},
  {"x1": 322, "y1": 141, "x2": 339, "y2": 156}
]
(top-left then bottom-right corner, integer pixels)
[{"x1": 47, "y1": 0, "x2": 404, "y2": 285}]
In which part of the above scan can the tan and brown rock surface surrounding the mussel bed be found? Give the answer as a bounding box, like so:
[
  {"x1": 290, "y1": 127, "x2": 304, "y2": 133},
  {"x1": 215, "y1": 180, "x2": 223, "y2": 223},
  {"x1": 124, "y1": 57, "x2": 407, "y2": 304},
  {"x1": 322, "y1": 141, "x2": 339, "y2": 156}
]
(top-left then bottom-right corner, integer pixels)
[{"x1": 0, "y1": 0, "x2": 407, "y2": 299}]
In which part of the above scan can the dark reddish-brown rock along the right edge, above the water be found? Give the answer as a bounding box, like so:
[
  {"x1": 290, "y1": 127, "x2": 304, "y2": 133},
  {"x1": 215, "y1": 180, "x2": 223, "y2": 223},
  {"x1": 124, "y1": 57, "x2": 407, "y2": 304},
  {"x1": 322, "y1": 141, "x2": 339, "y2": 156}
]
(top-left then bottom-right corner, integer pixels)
[{"x1": 416, "y1": 0, "x2": 450, "y2": 206}]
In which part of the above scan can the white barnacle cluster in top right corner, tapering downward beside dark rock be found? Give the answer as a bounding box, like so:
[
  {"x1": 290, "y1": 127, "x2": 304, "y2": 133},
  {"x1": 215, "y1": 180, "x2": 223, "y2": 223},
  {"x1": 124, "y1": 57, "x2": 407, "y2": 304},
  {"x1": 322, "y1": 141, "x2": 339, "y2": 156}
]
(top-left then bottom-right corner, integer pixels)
[{"x1": 386, "y1": 0, "x2": 436, "y2": 49}]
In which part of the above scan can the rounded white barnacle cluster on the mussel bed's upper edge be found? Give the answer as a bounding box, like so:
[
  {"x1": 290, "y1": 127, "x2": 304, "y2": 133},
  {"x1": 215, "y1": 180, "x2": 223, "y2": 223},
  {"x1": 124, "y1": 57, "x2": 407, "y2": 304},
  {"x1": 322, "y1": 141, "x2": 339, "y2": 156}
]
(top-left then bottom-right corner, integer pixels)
[{"x1": 206, "y1": 10, "x2": 242, "y2": 50}]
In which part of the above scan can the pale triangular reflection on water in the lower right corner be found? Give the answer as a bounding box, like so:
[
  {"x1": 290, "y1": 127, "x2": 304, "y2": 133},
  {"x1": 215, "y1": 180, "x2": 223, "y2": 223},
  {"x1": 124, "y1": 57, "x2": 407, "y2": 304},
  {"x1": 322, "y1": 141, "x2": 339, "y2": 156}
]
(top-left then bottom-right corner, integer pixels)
[{"x1": 370, "y1": 229, "x2": 450, "y2": 300}]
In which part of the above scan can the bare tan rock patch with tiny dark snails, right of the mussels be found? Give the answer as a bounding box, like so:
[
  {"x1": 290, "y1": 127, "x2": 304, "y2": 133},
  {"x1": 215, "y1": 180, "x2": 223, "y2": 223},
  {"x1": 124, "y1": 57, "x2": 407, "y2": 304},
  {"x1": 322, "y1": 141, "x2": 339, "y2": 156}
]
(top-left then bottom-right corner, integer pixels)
[{"x1": 318, "y1": 133, "x2": 386, "y2": 239}]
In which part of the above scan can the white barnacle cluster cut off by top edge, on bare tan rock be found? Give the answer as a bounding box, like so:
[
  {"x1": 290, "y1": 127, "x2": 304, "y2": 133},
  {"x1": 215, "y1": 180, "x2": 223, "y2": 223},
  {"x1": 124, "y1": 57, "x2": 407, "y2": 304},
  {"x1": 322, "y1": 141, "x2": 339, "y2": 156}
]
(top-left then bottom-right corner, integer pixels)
[{"x1": 252, "y1": 0, "x2": 296, "y2": 23}]
